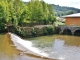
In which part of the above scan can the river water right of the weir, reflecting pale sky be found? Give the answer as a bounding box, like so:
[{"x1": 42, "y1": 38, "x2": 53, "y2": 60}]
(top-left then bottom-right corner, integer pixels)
[{"x1": 29, "y1": 35, "x2": 80, "y2": 60}]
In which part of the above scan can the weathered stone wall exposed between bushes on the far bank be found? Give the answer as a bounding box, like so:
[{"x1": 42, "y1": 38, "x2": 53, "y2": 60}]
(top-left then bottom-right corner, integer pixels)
[{"x1": 20, "y1": 25, "x2": 54, "y2": 36}]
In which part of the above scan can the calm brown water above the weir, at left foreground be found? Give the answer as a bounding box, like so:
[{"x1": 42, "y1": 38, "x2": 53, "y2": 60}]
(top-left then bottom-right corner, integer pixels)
[{"x1": 0, "y1": 34, "x2": 51, "y2": 60}]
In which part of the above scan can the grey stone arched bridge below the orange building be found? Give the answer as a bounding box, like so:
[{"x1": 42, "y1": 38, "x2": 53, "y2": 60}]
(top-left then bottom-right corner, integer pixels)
[{"x1": 57, "y1": 26, "x2": 80, "y2": 35}]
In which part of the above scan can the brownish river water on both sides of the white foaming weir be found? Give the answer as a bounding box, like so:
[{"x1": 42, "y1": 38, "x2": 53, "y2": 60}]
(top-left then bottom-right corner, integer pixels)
[{"x1": 0, "y1": 34, "x2": 80, "y2": 60}]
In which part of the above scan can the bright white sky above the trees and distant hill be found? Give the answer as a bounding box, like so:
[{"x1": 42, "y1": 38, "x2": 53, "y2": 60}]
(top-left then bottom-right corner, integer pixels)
[{"x1": 22, "y1": 0, "x2": 80, "y2": 9}]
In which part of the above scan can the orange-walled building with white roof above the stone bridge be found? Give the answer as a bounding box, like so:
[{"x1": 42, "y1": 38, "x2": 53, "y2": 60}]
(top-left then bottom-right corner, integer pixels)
[{"x1": 63, "y1": 13, "x2": 80, "y2": 26}]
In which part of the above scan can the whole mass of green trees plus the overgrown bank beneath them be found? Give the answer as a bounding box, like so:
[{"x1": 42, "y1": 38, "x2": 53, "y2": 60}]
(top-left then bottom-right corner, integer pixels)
[{"x1": 0, "y1": 0, "x2": 56, "y2": 37}]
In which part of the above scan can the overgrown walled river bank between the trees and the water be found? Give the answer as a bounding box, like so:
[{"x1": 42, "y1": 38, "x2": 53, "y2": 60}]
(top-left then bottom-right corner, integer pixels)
[{"x1": 8, "y1": 25, "x2": 55, "y2": 38}]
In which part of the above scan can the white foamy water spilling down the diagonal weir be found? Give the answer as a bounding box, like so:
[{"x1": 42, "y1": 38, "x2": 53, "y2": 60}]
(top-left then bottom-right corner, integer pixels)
[{"x1": 9, "y1": 33, "x2": 49, "y2": 57}]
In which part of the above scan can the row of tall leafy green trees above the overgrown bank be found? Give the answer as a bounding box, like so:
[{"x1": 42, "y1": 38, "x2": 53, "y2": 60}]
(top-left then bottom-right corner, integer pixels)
[{"x1": 0, "y1": 0, "x2": 54, "y2": 32}]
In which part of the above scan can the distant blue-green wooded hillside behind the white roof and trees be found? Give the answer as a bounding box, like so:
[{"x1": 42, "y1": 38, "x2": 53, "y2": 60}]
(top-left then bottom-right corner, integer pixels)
[{"x1": 52, "y1": 4, "x2": 80, "y2": 16}]
